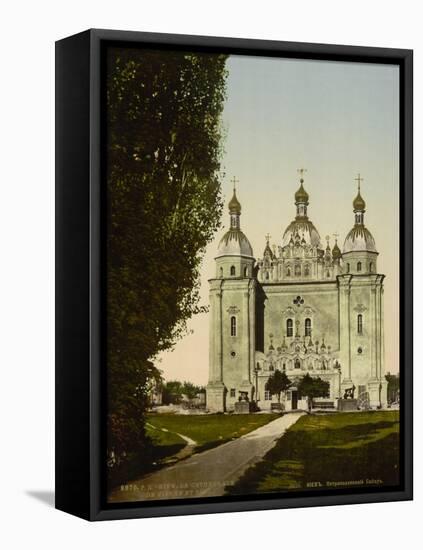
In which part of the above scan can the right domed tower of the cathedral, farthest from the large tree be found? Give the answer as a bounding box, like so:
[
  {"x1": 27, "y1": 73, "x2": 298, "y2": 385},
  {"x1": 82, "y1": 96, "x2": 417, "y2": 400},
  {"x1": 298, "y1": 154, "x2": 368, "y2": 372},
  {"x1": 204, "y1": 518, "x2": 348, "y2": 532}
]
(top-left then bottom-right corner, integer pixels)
[{"x1": 337, "y1": 174, "x2": 387, "y2": 408}]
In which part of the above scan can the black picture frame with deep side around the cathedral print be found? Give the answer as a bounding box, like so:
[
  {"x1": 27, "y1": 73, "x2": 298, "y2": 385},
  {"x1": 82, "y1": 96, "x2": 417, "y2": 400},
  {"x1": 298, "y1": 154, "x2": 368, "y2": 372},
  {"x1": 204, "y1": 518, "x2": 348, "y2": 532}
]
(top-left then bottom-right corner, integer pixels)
[{"x1": 56, "y1": 29, "x2": 413, "y2": 520}]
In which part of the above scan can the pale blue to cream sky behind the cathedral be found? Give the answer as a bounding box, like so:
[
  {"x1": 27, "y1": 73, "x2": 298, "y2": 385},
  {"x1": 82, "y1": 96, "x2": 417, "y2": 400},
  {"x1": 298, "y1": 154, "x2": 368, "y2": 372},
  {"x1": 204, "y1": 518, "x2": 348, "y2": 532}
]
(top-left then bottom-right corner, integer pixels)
[{"x1": 157, "y1": 56, "x2": 399, "y2": 385}]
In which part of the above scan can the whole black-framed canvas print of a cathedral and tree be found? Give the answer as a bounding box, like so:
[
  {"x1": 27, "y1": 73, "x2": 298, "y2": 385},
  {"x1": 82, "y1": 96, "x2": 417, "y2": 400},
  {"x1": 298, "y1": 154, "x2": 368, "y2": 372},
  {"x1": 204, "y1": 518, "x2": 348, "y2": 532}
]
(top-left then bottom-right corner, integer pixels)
[{"x1": 56, "y1": 30, "x2": 413, "y2": 520}]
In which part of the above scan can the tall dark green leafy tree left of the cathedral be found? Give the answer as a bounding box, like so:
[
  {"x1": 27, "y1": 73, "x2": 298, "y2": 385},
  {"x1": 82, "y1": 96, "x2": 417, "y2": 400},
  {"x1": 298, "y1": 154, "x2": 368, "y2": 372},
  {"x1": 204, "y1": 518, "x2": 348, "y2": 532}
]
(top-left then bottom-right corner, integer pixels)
[{"x1": 106, "y1": 48, "x2": 230, "y2": 470}]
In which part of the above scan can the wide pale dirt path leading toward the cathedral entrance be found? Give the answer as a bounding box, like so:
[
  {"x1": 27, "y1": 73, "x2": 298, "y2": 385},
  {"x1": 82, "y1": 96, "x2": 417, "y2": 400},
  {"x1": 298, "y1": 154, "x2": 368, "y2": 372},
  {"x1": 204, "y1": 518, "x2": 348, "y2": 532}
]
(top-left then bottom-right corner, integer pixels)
[{"x1": 109, "y1": 412, "x2": 304, "y2": 502}]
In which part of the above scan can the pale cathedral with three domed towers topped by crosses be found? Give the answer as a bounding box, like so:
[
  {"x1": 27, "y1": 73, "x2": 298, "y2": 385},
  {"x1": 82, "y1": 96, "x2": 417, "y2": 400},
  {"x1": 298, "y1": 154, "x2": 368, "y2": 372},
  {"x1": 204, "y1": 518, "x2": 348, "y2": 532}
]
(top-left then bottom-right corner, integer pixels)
[{"x1": 207, "y1": 170, "x2": 387, "y2": 412}]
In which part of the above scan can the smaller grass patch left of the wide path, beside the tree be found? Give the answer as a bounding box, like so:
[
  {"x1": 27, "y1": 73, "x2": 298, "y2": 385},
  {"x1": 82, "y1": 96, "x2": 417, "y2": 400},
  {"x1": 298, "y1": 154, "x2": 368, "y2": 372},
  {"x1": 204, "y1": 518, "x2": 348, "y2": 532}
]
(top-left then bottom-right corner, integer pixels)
[{"x1": 147, "y1": 414, "x2": 278, "y2": 452}]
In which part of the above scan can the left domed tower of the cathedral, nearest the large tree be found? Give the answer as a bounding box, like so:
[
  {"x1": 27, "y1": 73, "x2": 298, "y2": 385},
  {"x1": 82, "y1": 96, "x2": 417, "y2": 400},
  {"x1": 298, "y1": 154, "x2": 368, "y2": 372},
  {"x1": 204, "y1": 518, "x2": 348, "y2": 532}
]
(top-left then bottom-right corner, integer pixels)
[{"x1": 207, "y1": 178, "x2": 256, "y2": 412}]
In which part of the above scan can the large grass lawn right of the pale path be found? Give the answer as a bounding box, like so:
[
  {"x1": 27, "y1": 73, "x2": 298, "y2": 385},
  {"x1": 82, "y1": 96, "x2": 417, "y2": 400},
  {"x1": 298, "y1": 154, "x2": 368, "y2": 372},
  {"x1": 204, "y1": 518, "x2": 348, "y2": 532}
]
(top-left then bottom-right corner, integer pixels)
[{"x1": 227, "y1": 411, "x2": 399, "y2": 494}]
